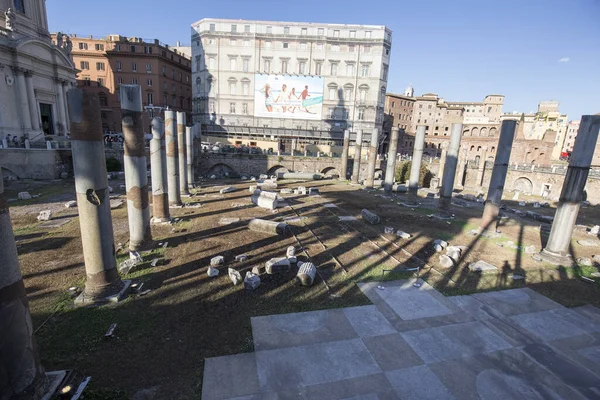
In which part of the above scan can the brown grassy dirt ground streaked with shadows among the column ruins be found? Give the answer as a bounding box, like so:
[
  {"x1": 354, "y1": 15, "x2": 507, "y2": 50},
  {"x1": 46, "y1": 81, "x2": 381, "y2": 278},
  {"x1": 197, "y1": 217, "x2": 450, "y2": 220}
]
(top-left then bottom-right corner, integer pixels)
[{"x1": 7, "y1": 181, "x2": 600, "y2": 399}]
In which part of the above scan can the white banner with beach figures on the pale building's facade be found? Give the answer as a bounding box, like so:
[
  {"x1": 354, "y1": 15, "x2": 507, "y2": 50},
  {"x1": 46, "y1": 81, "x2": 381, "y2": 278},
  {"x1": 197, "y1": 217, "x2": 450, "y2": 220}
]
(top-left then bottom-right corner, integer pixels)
[{"x1": 254, "y1": 74, "x2": 323, "y2": 120}]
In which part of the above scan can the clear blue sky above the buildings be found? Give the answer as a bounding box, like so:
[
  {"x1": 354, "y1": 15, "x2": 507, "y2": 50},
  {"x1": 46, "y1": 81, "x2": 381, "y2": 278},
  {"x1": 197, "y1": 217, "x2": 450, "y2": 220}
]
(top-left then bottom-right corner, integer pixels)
[{"x1": 47, "y1": 0, "x2": 600, "y2": 119}]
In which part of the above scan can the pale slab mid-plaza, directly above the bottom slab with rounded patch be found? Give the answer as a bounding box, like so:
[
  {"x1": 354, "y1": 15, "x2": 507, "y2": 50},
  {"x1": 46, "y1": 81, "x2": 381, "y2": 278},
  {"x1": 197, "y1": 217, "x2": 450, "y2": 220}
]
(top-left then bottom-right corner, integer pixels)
[{"x1": 401, "y1": 322, "x2": 512, "y2": 363}]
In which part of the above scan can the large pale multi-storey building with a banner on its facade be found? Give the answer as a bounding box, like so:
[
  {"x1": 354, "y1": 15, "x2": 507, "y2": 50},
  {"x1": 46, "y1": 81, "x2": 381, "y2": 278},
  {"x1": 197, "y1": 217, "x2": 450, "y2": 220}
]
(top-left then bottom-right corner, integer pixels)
[{"x1": 192, "y1": 19, "x2": 392, "y2": 145}]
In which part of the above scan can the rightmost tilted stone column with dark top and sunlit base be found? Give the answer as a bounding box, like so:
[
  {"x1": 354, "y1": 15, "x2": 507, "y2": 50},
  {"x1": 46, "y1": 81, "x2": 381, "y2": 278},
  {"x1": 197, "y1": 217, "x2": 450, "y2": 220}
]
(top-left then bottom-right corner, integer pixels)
[{"x1": 541, "y1": 115, "x2": 600, "y2": 265}]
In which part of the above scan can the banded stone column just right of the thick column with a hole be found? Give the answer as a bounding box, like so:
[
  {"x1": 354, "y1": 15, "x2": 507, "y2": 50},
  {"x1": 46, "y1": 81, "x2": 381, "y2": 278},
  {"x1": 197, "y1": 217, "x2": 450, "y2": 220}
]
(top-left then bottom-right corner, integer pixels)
[{"x1": 119, "y1": 85, "x2": 152, "y2": 251}]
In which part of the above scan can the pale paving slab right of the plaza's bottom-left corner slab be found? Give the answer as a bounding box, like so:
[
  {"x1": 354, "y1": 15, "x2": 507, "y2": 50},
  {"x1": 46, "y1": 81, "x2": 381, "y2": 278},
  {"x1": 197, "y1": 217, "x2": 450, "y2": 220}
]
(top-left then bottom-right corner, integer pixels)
[{"x1": 256, "y1": 339, "x2": 382, "y2": 391}]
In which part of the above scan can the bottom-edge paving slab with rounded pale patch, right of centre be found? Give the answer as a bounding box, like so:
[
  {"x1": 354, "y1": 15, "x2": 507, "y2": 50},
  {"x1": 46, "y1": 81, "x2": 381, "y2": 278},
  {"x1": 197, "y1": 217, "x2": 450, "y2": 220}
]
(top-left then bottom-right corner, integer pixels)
[{"x1": 428, "y1": 349, "x2": 582, "y2": 400}]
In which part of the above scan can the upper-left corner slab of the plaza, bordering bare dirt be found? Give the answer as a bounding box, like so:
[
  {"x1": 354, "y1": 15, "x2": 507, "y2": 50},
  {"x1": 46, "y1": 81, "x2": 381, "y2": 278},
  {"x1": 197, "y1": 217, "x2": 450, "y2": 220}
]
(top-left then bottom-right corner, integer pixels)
[{"x1": 251, "y1": 309, "x2": 358, "y2": 351}]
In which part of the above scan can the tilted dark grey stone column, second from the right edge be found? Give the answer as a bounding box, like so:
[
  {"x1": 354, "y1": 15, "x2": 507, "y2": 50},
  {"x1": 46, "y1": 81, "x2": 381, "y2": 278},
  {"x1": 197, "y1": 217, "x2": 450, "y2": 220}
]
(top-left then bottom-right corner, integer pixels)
[{"x1": 481, "y1": 120, "x2": 517, "y2": 230}]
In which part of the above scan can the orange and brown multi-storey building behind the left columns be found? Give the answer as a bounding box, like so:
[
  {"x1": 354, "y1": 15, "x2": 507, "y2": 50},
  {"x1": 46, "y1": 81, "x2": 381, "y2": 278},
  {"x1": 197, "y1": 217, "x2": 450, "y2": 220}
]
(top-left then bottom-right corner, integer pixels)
[{"x1": 52, "y1": 34, "x2": 192, "y2": 133}]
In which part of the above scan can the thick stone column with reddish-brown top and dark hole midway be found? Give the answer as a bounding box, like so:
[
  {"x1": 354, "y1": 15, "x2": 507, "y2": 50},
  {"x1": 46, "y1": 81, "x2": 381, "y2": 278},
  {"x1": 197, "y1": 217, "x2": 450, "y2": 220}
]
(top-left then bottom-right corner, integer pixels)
[{"x1": 67, "y1": 89, "x2": 131, "y2": 304}]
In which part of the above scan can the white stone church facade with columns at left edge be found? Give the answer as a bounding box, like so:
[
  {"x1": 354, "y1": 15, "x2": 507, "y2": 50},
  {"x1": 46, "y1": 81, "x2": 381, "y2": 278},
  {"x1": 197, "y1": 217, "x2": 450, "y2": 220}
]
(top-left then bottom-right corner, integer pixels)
[{"x1": 0, "y1": 0, "x2": 76, "y2": 141}]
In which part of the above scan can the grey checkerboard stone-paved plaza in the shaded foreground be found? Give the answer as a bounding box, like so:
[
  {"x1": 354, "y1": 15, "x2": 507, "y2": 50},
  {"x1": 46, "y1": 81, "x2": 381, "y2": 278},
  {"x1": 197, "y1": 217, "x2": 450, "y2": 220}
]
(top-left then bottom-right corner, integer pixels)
[{"x1": 203, "y1": 281, "x2": 600, "y2": 400}]
